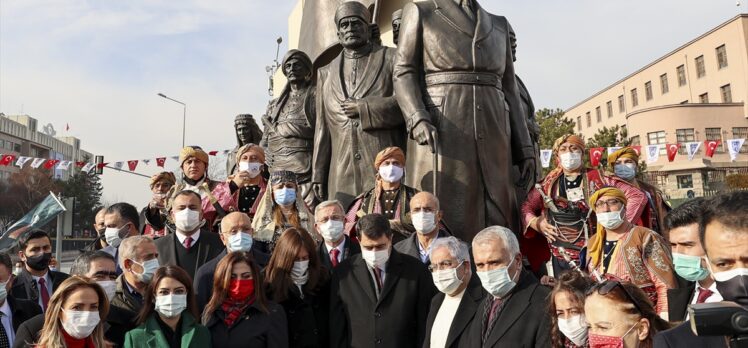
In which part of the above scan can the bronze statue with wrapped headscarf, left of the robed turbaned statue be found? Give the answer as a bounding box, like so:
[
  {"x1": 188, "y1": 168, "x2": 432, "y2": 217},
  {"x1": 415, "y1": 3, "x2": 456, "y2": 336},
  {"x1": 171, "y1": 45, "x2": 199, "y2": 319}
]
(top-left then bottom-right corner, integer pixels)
[{"x1": 260, "y1": 50, "x2": 316, "y2": 205}]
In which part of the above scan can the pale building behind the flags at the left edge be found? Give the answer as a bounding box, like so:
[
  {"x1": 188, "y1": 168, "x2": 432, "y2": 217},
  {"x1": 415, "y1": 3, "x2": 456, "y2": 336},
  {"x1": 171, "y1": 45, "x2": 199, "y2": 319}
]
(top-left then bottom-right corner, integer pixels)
[{"x1": 0, "y1": 113, "x2": 93, "y2": 180}]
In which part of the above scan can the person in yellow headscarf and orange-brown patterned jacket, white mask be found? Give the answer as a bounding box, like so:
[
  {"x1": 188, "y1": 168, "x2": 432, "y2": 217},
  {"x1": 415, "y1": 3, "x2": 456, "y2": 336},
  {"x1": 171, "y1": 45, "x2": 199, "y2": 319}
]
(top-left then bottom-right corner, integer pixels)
[{"x1": 586, "y1": 187, "x2": 677, "y2": 320}]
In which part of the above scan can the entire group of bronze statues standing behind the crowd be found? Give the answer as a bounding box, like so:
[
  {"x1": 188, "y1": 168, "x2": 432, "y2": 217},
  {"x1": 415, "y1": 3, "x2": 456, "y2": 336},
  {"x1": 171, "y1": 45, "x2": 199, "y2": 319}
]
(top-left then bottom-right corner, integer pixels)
[{"x1": 234, "y1": 0, "x2": 538, "y2": 240}]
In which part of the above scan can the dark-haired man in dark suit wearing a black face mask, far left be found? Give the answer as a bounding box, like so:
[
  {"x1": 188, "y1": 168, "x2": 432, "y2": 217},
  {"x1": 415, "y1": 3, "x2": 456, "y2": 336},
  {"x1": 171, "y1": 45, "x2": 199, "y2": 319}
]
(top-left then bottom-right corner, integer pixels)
[{"x1": 10, "y1": 230, "x2": 68, "y2": 311}]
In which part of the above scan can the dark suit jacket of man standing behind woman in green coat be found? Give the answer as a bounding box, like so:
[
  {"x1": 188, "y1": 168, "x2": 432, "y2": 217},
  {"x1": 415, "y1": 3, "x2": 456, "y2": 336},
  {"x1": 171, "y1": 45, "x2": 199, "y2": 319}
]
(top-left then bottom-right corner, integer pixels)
[{"x1": 153, "y1": 229, "x2": 226, "y2": 278}]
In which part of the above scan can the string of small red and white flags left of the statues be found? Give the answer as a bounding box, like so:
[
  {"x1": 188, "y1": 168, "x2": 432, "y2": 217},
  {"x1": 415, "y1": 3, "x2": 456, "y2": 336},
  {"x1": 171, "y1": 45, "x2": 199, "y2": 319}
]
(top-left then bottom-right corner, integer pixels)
[{"x1": 0, "y1": 150, "x2": 231, "y2": 173}]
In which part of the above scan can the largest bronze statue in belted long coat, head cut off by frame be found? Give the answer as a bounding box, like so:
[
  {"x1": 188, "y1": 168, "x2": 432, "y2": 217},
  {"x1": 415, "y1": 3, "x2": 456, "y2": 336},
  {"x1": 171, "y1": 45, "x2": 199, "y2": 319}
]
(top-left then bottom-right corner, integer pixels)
[{"x1": 394, "y1": 0, "x2": 535, "y2": 241}]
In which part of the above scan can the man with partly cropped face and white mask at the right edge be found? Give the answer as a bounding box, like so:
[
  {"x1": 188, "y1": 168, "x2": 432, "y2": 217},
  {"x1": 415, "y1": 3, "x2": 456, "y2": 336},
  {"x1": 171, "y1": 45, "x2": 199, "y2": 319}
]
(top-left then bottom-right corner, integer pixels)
[{"x1": 654, "y1": 191, "x2": 748, "y2": 348}]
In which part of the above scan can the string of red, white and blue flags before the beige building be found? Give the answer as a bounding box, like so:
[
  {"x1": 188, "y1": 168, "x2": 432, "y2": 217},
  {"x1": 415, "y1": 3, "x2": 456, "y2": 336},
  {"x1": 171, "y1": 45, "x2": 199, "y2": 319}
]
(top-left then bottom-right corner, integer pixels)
[{"x1": 540, "y1": 139, "x2": 745, "y2": 168}]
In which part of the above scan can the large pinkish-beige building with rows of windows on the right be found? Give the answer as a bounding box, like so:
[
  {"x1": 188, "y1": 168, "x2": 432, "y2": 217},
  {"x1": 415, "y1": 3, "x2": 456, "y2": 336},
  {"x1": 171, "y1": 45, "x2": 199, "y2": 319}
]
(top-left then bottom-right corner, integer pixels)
[{"x1": 565, "y1": 14, "x2": 748, "y2": 199}]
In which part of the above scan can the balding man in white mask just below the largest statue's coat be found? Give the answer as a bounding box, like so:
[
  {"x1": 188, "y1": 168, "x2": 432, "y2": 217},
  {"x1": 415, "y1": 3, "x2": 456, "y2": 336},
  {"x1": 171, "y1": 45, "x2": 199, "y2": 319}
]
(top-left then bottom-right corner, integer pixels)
[{"x1": 395, "y1": 191, "x2": 449, "y2": 265}]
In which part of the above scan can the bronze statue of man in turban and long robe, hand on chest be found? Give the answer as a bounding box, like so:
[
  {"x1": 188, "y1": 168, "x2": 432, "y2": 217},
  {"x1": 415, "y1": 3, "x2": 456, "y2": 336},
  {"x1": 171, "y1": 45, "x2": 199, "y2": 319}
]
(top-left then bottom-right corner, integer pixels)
[{"x1": 312, "y1": 1, "x2": 405, "y2": 206}]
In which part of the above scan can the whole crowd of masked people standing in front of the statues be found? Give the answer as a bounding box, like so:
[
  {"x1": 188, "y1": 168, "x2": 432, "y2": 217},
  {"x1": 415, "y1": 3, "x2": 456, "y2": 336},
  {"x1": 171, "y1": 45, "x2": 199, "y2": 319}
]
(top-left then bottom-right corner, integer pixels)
[{"x1": 0, "y1": 135, "x2": 748, "y2": 348}]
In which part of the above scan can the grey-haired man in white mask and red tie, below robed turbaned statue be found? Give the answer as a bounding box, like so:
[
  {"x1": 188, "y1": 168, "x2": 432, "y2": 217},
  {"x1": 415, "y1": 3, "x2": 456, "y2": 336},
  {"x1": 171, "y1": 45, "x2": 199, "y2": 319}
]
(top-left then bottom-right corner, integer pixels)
[{"x1": 314, "y1": 200, "x2": 361, "y2": 272}]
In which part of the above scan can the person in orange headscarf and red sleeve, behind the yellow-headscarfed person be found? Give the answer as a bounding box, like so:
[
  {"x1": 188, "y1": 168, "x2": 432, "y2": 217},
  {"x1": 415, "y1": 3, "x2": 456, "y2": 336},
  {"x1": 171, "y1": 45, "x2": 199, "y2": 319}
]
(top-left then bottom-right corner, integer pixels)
[{"x1": 608, "y1": 146, "x2": 670, "y2": 239}]
